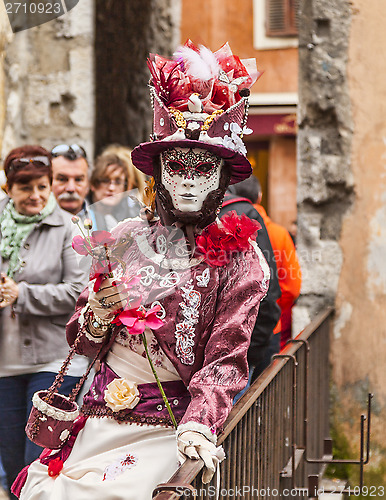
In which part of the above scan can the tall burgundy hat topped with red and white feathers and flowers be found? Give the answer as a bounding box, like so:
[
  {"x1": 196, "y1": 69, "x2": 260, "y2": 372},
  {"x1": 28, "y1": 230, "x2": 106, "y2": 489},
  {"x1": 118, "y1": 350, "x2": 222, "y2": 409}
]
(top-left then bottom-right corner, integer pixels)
[{"x1": 132, "y1": 40, "x2": 261, "y2": 184}]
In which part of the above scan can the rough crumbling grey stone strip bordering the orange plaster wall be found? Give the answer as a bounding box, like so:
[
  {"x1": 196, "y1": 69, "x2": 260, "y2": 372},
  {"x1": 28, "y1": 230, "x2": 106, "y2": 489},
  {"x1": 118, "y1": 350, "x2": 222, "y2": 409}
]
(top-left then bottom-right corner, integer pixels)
[{"x1": 294, "y1": 0, "x2": 354, "y2": 332}]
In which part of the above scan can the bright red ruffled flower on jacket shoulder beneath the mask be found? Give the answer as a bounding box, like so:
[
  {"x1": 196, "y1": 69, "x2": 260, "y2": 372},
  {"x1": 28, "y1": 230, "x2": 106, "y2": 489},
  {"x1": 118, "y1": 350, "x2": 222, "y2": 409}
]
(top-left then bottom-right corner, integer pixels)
[{"x1": 196, "y1": 211, "x2": 261, "y2": 267}]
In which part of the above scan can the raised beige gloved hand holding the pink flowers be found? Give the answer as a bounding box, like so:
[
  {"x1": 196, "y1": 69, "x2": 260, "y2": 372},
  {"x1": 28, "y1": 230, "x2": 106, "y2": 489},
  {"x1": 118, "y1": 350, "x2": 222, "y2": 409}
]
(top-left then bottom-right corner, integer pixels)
[{"x1": 88, "y1": 277, "x2": 128, "y2": 320}]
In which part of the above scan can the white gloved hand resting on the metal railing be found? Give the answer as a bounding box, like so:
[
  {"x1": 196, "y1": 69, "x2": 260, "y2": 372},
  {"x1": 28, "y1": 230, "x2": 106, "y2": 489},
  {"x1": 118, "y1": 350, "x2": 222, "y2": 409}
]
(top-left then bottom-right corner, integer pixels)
[{"x1": 177, "y1": 431, "x2": 225, "y2": 484}]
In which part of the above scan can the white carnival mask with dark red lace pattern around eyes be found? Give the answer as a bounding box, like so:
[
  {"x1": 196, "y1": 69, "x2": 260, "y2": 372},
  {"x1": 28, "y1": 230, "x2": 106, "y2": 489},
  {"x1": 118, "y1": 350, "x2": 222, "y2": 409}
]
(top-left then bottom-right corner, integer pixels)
[{"x1": 161, "y1": 148, "x2": 222, "y2": 212}]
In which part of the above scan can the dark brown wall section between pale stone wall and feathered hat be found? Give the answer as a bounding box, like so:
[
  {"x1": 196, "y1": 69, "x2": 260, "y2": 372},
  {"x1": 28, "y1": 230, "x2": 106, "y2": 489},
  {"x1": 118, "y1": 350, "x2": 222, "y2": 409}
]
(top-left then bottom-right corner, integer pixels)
[{"x1": 95, "y1": 0, "x2": 180, "y2": 152}]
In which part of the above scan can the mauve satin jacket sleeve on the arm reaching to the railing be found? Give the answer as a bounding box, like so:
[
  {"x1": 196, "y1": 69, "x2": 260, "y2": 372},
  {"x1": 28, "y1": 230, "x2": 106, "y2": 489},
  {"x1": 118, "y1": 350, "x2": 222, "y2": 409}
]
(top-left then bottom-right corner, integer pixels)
[{"x1": 180, "y1": 248, "x2": 269, "y2": 439}]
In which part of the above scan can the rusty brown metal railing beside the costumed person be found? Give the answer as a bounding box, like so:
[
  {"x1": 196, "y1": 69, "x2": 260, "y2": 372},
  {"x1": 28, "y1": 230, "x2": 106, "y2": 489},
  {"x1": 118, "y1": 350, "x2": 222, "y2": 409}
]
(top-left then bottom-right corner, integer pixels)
[{"x1": 154, "y1": 308, "x2": 333, "y2": 500}]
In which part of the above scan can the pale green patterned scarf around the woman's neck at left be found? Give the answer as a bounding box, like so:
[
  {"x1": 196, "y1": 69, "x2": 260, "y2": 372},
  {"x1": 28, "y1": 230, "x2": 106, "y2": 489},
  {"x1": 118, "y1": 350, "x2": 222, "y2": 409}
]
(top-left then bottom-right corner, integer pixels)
[{"x1": 0, "y1": 193, "x2": 56, "y2": 278}]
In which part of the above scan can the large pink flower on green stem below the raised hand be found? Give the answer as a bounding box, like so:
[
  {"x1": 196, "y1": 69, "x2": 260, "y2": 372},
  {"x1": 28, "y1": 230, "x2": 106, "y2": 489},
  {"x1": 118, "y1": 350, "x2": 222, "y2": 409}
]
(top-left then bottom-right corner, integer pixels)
[{"x1": 113, "y1": 299, "x2": 164, "y2": 335}]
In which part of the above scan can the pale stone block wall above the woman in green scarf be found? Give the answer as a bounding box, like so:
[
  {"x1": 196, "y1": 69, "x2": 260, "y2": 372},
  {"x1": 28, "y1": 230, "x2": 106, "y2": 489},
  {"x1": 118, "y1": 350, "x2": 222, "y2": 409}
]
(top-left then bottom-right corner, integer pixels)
[{"x1": 2, "y1": 0, "x2": 94, "y2": 158}]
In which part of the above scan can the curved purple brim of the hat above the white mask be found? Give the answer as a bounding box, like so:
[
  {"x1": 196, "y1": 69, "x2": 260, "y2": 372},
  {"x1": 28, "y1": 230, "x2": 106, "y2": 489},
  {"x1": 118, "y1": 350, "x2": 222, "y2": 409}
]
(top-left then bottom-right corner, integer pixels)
[{"x1": 131, "y1": 139, "x2": 252, "y2": 184}]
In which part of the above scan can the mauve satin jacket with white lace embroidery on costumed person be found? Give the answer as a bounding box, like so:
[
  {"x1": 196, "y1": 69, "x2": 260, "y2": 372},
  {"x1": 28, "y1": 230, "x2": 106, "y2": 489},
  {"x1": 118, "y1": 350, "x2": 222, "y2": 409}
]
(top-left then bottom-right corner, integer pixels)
[{"x1": 67, "y1": 219, "x2": 269, "y2": 433}]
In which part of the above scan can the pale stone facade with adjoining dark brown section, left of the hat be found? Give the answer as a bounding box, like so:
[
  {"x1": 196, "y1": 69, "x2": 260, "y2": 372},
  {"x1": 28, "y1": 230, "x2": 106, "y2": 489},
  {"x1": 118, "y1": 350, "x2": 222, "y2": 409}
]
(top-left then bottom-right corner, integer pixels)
[{"x1": 0, "y1": 0, "x2": 180, "y2": 159}]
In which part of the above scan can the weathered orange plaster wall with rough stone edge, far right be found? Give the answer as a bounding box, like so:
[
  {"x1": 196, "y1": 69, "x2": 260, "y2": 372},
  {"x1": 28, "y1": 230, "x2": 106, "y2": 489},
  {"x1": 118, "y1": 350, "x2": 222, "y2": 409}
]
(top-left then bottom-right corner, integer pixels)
[{"x1": 294, "y1": 0, "x2": 386, "y2": 486}]
